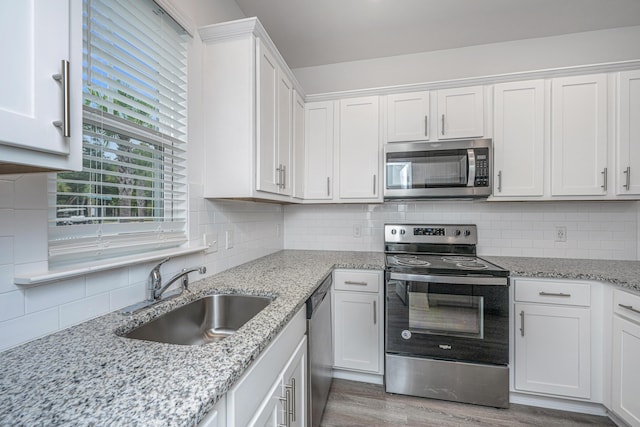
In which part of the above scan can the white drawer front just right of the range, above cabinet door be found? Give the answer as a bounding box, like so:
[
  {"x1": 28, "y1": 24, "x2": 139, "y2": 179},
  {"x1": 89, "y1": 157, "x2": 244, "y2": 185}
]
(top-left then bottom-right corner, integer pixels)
[{"x1": 515, "y1": 279, "x2": 591, "y2": 307}]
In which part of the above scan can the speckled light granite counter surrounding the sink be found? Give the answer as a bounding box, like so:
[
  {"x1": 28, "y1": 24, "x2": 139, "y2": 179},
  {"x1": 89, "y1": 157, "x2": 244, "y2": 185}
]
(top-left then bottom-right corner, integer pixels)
[{"x1": 0, "y1": 251, "x2": 384, "y2": 426}]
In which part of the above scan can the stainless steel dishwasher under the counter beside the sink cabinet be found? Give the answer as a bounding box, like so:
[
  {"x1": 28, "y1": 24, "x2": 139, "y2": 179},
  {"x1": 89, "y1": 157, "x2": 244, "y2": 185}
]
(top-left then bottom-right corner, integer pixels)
[{"x1": 307, "y1": 275, "x2": 333, "y2": 427}]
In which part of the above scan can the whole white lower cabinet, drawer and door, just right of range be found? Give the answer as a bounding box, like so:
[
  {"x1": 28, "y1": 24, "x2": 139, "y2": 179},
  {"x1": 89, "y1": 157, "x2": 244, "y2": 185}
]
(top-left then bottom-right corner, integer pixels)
[{"x1": 514, "y1": 280, "x2": 591, "y2": 399}]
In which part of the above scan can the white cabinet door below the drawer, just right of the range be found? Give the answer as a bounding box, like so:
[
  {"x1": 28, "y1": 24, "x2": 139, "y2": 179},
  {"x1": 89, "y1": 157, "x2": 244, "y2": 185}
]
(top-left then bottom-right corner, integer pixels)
[{"x1": 515, "y1": 304, "x2": 591, "y2": 398}]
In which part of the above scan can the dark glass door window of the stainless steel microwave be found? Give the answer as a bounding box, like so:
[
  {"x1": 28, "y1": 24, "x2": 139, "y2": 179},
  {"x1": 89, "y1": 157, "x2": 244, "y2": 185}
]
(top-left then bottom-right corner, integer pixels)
[{"x1": 386, "y1": 150, "x2": 468, "y2": 189}]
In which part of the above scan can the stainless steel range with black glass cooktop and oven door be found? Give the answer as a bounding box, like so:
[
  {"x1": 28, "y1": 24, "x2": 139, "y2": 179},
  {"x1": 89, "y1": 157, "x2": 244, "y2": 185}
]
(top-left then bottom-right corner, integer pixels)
[{"x1": 384, "y1": 224, "x2": 509, "y2": 408}]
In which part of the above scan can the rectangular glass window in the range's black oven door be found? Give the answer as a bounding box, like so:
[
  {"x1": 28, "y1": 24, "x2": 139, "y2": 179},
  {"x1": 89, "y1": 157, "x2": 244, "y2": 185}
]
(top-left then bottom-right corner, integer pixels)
[{"x1": 407, "y1": 286, "x2": 484, "y2": 339}]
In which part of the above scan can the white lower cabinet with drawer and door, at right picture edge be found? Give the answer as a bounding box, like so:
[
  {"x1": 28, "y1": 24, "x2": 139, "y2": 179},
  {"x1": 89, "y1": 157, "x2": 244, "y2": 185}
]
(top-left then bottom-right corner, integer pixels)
[{"x1": 611, "y1": 290, "x2": 640, "y2": 426}]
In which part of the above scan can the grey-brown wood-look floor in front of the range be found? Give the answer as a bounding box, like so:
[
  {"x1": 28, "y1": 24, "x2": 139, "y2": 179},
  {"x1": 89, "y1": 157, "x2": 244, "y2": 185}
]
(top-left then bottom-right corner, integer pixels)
[{"x1": 321, "y1": 379, "x2": 615, "y2": 427}]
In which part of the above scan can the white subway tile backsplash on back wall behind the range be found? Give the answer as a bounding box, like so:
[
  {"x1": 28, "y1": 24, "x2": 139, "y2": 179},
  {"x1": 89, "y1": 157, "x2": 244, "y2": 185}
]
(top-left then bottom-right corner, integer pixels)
[{"x1": 284, "y1": 201, "x2": 638, "y2": 260}]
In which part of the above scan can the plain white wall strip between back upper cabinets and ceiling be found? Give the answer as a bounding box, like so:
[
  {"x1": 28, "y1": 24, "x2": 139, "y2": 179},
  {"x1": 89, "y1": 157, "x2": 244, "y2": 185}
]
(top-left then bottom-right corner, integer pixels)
[{"x1": 293, "y1": 23, "x2": 640, "y2": 94}]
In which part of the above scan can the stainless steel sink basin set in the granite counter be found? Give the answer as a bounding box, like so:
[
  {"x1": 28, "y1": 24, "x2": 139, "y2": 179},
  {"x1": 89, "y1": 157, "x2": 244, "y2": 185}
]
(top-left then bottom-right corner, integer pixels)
[{"x1": 125, "y1": 294, "x2": 272, "y2": 345}]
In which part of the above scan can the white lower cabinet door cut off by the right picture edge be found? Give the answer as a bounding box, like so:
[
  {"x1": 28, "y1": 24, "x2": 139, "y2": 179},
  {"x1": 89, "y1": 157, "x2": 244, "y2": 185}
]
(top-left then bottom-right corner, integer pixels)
[{"x1": 611, "y1": 316, "x2": 640, "y2": 426}]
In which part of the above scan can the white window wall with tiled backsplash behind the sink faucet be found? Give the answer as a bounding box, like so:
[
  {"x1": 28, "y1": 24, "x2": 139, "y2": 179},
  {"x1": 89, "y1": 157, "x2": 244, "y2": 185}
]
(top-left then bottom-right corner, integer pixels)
[{"x1": 0, "y1": 0, "x2": 283, "y2": 351}]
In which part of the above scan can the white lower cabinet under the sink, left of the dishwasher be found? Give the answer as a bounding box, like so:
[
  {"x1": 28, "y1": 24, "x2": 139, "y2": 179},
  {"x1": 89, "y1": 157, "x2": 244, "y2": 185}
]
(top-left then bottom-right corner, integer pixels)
[{"x1": 226, "y1": 307, "x2": 307, "y2": 427}]
